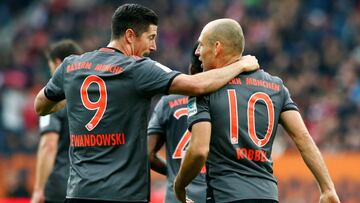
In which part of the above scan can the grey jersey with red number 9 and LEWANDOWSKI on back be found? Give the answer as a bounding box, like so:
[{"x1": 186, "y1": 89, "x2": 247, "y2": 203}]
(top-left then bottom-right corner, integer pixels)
[{"x1": 46, "y1": 48, "x2": 178, "y2": 202}]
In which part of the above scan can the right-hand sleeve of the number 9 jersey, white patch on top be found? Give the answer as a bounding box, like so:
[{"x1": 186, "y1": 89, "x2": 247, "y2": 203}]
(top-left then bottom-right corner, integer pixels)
[{"x1": 134, "y1": 59, "x2": 180, "y2": 96}]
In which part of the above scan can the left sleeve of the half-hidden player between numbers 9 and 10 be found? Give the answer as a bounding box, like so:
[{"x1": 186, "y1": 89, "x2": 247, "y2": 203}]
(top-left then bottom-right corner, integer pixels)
[{"x1": 147, "y1": 97, "x2": 166, "y2": 135}]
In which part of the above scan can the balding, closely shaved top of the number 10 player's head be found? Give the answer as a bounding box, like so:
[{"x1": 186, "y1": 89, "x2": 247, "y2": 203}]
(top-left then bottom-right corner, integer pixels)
[{"x1": 202, "y1": 18, "x2": 245, "y2": 54}]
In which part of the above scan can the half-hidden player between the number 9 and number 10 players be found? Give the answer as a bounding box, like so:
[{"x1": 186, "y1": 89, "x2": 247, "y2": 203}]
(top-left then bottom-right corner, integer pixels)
[{"x1": 148, "y1": 43, "x2": 206, "y2": 203}]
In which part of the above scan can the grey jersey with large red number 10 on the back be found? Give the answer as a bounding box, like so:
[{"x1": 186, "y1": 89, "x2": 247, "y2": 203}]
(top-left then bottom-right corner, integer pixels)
[{"x1": 189, "y1": 70, "x2": 297, "y2": 202}]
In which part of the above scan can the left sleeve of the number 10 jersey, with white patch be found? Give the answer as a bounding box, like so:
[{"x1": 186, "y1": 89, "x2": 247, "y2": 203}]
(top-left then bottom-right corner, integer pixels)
[{"x1": 188, "y1": 95, "x2": 211, "y2": 131}]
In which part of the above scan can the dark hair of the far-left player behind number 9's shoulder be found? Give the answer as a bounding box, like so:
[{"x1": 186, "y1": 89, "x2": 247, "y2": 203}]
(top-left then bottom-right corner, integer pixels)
[{"x1": 45, "y1": 39, "x2": 84, "y2": 61}]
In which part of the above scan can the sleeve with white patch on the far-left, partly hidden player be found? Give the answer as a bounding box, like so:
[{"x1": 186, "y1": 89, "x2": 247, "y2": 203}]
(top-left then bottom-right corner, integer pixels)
[{"x1": 39, "y1": 113, "x2": 61, "y2": 135}]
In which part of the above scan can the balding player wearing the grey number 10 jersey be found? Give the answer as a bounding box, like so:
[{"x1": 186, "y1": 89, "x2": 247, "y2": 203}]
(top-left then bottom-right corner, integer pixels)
[{"x1": 174, "y1": 19, "x2": 339, "y2": 203}]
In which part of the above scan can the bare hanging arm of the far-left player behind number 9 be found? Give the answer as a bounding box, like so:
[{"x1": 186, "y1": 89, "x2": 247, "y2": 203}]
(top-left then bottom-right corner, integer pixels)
[{"x1": 31, "y1": 132, "x2": 59, "y2": 203}]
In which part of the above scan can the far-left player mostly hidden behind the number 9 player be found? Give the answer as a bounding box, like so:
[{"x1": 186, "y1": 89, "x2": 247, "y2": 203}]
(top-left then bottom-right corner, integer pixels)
[{"x1": 31, "y1": 40, "x2": 83, "y2": 203}]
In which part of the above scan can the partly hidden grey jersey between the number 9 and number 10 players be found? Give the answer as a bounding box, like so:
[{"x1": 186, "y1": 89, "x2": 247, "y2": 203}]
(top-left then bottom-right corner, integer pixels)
[{"x1": 148, "y1": 95, "x2": 206, "y2": 203}]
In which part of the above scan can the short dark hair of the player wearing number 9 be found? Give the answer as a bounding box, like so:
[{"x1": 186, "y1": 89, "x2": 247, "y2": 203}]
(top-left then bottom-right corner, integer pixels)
[{"x1": 111, "y1": 4, "x2": 158, "y2": 40}]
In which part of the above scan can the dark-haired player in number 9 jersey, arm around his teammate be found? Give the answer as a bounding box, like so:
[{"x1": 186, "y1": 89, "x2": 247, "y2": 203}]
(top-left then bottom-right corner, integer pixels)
[{"x1": 35, "y1": 4, "x2": 258, "y2": 202}]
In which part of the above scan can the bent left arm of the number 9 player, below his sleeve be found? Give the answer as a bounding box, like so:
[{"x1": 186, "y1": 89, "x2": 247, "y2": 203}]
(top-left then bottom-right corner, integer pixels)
[{"x1": 34, "y1": 88, "x2": 66, "y2": 116}]
